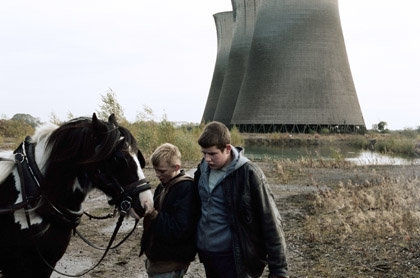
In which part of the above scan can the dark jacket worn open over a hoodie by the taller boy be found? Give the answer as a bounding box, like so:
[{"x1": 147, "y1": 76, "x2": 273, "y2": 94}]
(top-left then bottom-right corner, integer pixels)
[{"x1": 194, "y1": 151, "x2": 287, "y2": 277}]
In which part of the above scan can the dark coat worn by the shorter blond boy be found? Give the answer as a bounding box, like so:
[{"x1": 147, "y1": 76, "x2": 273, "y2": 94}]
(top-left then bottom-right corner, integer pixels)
[{"x1": 140, "y1": 172, "x2": 198, "y2": 262}]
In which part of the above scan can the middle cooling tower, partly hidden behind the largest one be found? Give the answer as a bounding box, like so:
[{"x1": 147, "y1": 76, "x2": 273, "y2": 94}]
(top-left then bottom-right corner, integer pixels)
[{"x1": 213, "y1": 0, "x2": 259, "y2": 126}]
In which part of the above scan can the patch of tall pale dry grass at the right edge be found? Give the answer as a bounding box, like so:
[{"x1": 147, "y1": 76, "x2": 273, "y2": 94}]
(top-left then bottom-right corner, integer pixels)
[{"x1": 306, "y1": 179, "x2": 420, "y2": 242}]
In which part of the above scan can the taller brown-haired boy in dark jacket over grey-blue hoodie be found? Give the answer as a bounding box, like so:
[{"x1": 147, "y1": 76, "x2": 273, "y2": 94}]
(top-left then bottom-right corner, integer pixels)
[{"x1": 194, "y1": 122, "x2": 287, "y2": 278}]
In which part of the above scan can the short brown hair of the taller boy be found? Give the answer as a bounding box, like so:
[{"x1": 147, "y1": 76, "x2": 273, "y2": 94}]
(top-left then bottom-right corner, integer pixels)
[{"x1": 198, "y1": 121, "x2": 230, "y2": 150}]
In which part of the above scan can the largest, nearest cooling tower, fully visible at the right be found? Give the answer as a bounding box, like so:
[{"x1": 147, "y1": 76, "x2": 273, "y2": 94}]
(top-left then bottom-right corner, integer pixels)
[{"x1": 231, "y1": 0, "x2": 364, "y2": 131}]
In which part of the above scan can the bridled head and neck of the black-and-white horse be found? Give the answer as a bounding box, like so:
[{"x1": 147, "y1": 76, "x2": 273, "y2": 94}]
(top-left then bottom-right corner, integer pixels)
[{"x1": 42, "y1": 113, "x2": 153, "y2": 217}]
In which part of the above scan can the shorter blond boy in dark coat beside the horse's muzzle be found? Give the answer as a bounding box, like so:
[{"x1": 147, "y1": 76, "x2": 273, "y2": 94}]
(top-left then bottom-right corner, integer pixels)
[{"x1": 140, "y1": 143, "x2": 198, "y2": 278}]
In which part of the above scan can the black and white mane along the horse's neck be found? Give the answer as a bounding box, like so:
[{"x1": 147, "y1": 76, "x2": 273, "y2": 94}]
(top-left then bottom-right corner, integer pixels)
[{"x1": 0, "y1": 117, "x2": 138, "y2": 182}]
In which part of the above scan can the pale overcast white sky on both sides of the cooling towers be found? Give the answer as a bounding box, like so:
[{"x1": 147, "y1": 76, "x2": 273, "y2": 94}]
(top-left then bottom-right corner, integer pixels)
[{"x1": 0, "y1": 0, "x2": 420, "y2": 129}]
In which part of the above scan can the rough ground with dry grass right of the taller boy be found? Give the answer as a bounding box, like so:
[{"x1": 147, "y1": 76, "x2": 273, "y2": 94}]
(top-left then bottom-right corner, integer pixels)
[{"x1": 264, "y1": 155, "x2": 420, "y2": 277}]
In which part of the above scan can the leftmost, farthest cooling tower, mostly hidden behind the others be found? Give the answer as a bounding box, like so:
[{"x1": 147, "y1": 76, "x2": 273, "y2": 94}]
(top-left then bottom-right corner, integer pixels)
[{"x1": 202, "y1": 12, "x2": 234, "y2": 123}]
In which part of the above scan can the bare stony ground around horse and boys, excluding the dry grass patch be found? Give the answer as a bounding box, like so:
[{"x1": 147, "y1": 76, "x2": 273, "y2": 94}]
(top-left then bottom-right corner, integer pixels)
[{"x1": 46, "y1": 161, "x2": 420, "y2": 277}]
